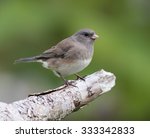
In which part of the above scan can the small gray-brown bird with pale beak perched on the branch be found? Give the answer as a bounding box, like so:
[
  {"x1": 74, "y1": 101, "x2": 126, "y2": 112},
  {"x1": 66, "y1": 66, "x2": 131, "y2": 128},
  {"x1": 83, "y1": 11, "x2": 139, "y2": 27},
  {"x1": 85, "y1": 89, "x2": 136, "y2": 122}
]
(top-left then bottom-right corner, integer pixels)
[{"x1": 15, "y1": 29, "x2": 98, "y2": 86}]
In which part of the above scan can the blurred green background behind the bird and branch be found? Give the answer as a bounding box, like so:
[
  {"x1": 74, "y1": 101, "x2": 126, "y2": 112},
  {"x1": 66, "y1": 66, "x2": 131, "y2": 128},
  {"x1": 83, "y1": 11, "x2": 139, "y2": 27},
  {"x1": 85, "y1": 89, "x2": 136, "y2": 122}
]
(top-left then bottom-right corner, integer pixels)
[{"x1": 0, "y1": 0, "x2": 150, "y2": 120}]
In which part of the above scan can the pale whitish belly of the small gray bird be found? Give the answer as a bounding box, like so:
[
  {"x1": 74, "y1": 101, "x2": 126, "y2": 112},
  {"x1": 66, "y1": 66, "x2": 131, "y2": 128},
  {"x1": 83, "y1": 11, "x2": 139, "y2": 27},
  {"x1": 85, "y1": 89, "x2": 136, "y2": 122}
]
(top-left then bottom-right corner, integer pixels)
[{"x1": 55, "y1": 59, "x2": 91, "y2": 76}]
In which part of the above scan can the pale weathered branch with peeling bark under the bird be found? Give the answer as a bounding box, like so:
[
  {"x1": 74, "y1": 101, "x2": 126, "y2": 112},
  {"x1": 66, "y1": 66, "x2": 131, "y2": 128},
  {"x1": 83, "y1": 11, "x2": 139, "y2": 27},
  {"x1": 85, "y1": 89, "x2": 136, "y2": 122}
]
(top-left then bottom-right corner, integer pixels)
[{"x1": 0, "y1": 70, "x2": 115, "y2": 120}]
